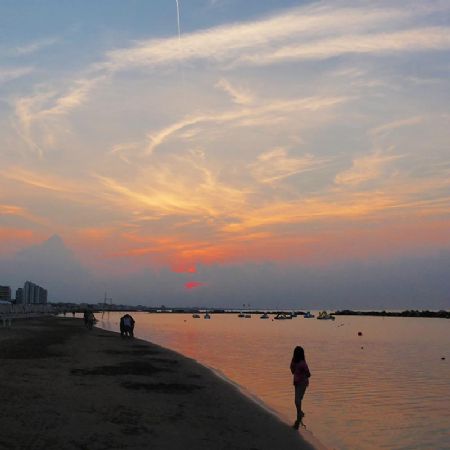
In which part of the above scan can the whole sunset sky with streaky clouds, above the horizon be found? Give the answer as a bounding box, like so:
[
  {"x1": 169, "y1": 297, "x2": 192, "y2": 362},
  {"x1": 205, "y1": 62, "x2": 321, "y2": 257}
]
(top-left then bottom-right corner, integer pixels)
[{"x1": 0, "y1": 0, "x2": 450, "y2": 309}]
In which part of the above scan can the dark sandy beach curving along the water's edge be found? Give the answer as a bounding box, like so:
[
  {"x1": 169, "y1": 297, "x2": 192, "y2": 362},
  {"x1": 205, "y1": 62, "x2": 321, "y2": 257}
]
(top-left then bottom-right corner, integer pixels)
[{"x1": 0, "y1": 317, "x2": 313, "y2": 450}]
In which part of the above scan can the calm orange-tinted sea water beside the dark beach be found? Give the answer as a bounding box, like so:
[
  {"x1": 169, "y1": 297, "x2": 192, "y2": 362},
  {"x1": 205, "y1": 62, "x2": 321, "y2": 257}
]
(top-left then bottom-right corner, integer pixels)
[{"x1": 98, "y1": 313, "x2": 450, "y2": 450}]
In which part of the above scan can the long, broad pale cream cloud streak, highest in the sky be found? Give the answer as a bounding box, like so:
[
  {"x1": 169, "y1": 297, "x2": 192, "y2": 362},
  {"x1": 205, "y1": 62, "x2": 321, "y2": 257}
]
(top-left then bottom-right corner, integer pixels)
[{"x1": 100, "y1": 4, "x2": 450, "y2": 71}]
